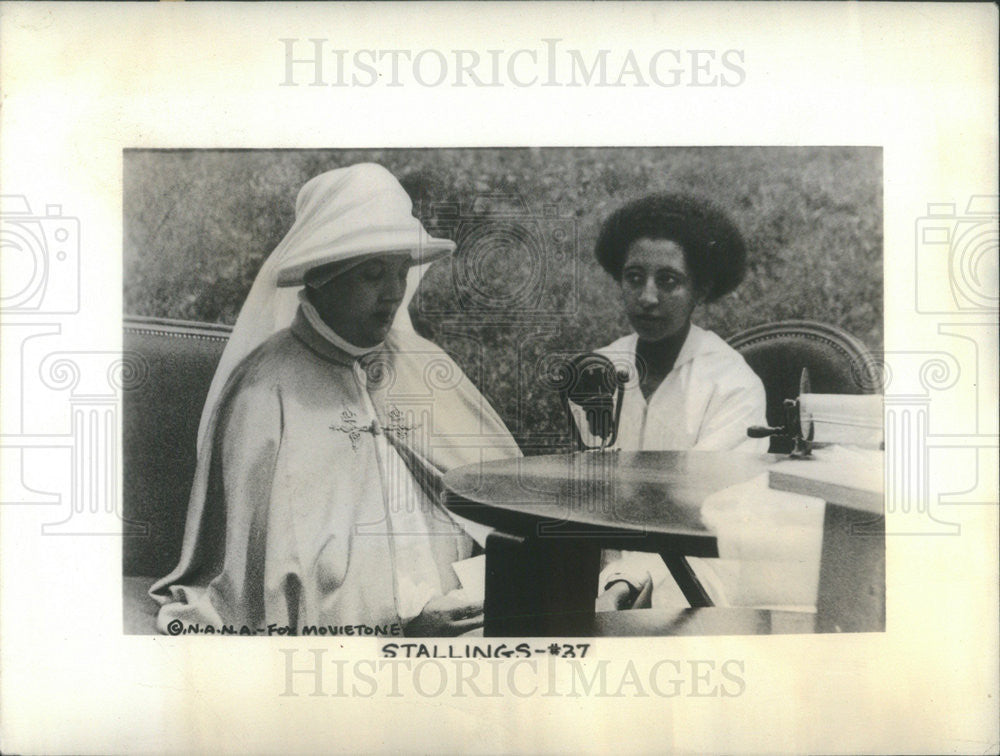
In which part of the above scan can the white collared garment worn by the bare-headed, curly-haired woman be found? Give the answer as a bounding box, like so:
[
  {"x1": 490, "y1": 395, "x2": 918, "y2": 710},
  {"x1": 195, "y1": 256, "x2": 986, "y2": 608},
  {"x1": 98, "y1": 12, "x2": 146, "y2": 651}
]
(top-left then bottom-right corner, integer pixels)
[{"x1": 581, "y1": 325, "x2": 768, "y2": 608}]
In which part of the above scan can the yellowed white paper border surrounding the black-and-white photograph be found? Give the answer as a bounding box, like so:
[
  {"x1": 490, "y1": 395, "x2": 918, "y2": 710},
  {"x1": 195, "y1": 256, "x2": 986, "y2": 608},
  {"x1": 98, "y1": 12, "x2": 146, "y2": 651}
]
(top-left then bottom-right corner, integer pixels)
[{"x1": 0, "y1": 3, "x2": 1000, "y2": 753}]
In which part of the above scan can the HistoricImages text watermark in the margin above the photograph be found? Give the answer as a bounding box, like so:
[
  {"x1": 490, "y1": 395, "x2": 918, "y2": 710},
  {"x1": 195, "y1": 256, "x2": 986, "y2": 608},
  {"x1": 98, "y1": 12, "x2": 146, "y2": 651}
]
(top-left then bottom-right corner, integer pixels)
[{"x1": 278, "y1": 37, "x2": 747, "y2": 88}]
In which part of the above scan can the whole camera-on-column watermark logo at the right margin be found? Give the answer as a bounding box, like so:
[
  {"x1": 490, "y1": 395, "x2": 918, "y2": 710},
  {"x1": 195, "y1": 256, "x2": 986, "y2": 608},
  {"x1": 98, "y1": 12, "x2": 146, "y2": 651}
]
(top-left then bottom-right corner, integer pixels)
[{"x1": 881, "y1": 195, "x2": 1000, "y2": 535}]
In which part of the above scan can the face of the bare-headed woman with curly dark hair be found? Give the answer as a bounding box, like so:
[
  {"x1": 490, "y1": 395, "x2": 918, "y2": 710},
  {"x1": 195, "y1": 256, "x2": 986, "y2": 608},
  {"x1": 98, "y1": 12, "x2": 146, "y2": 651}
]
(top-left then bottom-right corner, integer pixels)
[{"x1": 621, "y1": 238, "x2": 705, "y2": 341}]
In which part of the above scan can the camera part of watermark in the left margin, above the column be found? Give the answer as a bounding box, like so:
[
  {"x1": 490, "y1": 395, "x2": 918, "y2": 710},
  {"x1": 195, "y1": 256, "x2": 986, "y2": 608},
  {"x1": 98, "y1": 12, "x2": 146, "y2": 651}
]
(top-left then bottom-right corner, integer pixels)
[{"x1": 0, "y1": 195, "x2": 80, "y2": 314}]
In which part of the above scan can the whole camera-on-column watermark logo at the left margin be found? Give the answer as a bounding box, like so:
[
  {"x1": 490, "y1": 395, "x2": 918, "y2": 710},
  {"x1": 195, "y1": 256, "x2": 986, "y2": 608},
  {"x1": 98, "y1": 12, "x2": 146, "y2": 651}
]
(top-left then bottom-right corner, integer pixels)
[{"x1": 0, "y1": 195, "x2": 146, "y2": 536}]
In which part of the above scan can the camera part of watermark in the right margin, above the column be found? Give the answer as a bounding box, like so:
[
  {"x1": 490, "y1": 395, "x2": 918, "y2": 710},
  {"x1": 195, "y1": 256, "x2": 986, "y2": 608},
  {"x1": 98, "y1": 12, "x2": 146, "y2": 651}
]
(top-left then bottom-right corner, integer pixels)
[{"x1": 916, "y1": 195, "x2": 1000, "y2": 314}]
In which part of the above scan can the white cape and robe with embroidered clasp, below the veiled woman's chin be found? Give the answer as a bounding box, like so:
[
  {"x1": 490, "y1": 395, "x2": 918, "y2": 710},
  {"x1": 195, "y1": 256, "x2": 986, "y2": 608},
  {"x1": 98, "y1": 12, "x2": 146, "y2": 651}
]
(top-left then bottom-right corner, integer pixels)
[{"x1": 150, "y1": 311, "x2": 520, "y2": 633}]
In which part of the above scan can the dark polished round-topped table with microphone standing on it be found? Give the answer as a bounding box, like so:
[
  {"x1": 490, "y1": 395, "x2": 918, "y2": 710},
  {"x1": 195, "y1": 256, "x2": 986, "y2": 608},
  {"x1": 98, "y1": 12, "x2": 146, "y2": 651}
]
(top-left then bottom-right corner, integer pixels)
[{"x1": 444, "y1": 451, "x2": 784, "y2": 637}]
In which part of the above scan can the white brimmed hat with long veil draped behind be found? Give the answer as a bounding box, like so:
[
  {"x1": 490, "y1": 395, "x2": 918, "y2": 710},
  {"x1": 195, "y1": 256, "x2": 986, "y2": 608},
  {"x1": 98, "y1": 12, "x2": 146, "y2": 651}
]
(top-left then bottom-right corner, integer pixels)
[{"x1": 198, "y1": 163, "x2": 455, "y2": 451}]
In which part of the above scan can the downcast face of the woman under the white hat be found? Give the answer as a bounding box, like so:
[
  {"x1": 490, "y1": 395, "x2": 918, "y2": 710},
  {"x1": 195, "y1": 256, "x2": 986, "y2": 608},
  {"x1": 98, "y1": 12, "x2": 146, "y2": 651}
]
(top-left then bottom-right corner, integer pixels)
[{"x1": 309, "y1": 254, "x2": 411, "y2": 347}]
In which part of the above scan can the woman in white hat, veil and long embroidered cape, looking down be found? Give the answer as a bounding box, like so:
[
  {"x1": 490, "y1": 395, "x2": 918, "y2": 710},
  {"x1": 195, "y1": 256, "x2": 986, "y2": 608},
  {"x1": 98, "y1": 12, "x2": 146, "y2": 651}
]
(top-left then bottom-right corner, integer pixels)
[{"x1": 150, "y1": 164, "x2": 520, "y2": 635}]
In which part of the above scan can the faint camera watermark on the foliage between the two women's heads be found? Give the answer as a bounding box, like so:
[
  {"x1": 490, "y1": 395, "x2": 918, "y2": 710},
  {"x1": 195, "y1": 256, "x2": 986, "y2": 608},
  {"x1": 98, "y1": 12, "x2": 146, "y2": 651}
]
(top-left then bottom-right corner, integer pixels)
[{"x1": 416, "y1": 194, "x2": 579, "y2": 317}]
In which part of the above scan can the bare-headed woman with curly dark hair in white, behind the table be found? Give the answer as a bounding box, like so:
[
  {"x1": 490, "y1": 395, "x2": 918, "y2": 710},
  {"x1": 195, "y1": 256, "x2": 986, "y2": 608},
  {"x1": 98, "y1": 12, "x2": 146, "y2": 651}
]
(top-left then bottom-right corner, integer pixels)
[{"x1": 580, "y1": 194, "x2": 768, "y2": 607}]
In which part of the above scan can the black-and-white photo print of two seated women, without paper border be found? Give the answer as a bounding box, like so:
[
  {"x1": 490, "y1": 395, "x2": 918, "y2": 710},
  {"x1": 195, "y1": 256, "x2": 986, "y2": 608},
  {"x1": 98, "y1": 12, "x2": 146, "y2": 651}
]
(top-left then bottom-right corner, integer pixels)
[{"x1": 123, "y1": 147, "x2": 885, "y2": 637}]
